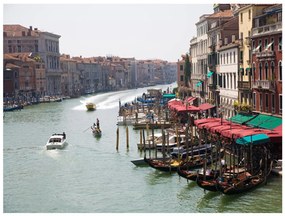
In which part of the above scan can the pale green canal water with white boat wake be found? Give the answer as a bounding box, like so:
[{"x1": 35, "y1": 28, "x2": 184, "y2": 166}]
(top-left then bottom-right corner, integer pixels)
[{"x1": 3, "y1": 86, "x2": 282, "y2": 213}]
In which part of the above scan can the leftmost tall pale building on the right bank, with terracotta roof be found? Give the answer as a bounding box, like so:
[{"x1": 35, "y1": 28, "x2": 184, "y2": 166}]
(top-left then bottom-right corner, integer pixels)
[{"x1": 190, "y1": 4, "x2": 233, "y2": 104}]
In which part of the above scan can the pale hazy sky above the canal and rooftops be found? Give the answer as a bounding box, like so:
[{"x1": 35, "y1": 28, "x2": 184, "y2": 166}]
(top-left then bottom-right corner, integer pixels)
[{"x1": 3, "y1": 3, "x2": 213, "y2": 61}]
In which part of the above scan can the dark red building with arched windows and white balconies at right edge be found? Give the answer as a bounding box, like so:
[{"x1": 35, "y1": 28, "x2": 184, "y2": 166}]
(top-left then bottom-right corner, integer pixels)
[{"x1": 251, "y1": 4, "x2": 282, "y2": 116}]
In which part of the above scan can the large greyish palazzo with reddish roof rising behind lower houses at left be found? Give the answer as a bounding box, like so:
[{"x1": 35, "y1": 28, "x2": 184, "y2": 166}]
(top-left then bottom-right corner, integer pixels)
[{"x1": 3, "y1": 25, "x2": 61, "y2": 95}]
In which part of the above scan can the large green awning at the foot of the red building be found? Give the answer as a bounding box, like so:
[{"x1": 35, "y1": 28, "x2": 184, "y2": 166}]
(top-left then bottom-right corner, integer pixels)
[{"x1": 246, "y1": 114, "x2": 282, "y2": 130}]
